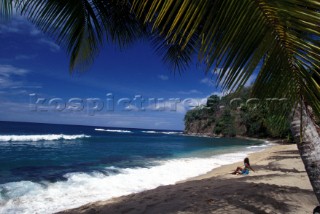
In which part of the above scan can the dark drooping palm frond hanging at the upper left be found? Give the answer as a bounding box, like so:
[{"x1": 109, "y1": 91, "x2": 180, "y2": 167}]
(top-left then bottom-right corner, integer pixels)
[{"x1": 15, "y1": 0, "x2": 104, "y2": 70}]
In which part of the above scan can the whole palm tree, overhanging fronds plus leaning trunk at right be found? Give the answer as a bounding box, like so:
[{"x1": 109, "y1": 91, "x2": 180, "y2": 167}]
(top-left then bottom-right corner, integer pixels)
[{"x1": 0, "y1": 0, "x2": 320, "y2": 202}]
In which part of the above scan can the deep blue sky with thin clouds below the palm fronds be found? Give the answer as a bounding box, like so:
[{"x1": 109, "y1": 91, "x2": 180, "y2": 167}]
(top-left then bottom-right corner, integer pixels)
[{"x1": 0, "y1": 16, "x2": 255, "y2": 130}]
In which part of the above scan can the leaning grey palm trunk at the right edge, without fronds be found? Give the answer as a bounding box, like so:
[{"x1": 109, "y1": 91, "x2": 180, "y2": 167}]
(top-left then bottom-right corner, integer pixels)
[{"x1": 291, "y1": 104, "x2": 320, "y2": 203}]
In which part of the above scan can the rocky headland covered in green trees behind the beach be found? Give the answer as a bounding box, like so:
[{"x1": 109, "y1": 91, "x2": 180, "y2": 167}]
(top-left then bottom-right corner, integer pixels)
[{"x1": 184, "y1": 88, "x2": 291, "y2": 139}]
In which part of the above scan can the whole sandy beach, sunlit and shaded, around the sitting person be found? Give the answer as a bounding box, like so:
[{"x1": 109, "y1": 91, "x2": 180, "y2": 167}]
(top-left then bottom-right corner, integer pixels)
[{"x1": 62, "y1": 145, "x2": 318, "y2": 214}]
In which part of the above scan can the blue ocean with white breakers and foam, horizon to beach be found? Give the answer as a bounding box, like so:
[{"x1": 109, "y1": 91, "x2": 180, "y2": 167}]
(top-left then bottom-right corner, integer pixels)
[{"x1": 0, "y1": 122, "x2": 269, "y2": 213}]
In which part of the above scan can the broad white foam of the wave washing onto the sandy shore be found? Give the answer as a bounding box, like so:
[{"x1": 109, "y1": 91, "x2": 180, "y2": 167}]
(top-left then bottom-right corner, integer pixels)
[{"x1": 0, "y1": 152, "x2": 246, "y2": 214}]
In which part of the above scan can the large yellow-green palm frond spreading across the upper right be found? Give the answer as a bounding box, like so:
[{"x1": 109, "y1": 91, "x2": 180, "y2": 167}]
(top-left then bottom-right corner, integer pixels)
[{"x1": 133, "y1": 0, "x2": 320, "y2": 120}]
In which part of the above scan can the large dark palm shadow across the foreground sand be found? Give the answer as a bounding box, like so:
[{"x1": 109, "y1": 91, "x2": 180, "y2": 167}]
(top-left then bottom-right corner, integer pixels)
[{"x1": 59, "y1": 170, "x2": 314, "y2": 214}]
